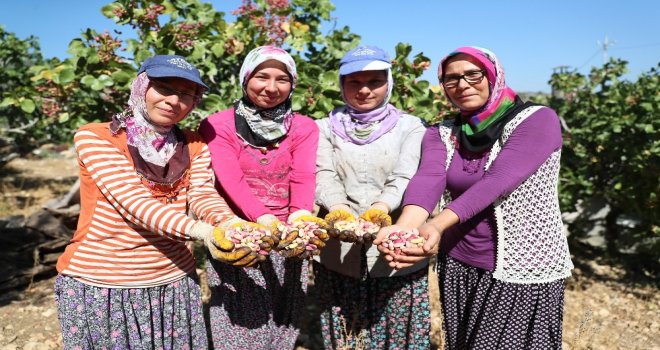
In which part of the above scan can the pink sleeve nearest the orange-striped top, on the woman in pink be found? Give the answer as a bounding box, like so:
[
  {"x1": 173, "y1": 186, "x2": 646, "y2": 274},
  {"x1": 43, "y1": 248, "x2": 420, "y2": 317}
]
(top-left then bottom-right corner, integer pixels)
[{"x1": 199, "y1": 112, "x2": 270, "y2": 221}]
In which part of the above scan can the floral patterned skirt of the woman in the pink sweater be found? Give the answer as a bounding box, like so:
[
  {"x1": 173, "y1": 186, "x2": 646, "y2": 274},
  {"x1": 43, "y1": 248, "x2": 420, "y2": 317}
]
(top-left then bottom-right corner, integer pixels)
[{"x1": 206, "y1": 252, "x2": 309, "y2": 350}]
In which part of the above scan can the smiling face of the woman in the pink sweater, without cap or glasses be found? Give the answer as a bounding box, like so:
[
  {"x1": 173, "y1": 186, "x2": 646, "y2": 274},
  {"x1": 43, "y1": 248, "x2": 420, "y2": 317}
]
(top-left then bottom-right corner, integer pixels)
[{"x1": 245, "y1": 60, "x2": 291, "y2": 109}]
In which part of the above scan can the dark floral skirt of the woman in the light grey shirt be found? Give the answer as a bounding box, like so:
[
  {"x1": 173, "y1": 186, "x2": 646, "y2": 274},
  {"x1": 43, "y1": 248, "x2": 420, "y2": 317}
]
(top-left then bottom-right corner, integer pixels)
[{"x1": 314, "y1": 263, "x2": 431, "y2": 349}]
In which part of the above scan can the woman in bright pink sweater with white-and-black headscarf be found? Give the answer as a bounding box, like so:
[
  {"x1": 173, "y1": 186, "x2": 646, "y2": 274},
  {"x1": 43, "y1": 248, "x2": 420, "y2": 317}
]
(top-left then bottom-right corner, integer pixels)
[{"x1": 199, "y1": 46, "x2": 319, "y2": 349}]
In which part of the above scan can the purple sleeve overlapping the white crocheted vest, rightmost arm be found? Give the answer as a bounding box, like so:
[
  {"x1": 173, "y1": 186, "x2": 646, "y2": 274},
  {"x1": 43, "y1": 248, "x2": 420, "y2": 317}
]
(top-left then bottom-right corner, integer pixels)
[{"x1": 447, "y1": 108, "x2": 562, "y2": 222}]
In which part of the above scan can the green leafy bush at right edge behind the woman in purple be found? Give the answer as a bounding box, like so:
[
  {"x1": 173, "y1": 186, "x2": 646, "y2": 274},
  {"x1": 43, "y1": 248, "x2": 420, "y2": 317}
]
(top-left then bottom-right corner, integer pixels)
[{"x1": 550, "y1": 59, "x2": 660, "y2": 262}]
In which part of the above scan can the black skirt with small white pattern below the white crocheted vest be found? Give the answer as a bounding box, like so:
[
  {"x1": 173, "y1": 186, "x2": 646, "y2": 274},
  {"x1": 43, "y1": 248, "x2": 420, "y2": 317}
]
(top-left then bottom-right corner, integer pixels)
[{"x1": 438, "y1": 254, "x2": 564, "y2": 349}]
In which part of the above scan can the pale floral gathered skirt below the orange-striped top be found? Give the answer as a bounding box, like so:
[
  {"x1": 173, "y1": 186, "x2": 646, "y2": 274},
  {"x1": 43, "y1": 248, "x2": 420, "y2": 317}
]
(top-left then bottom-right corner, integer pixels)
[{"x1": 55, "y1": 275, "x2": 208, "y2": 350}]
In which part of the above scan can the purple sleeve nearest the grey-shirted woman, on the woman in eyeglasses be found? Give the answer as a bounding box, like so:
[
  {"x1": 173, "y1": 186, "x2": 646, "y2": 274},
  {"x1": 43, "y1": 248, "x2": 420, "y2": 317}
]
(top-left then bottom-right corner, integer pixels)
[{"x1": 401, "y1": 126, "x2": 447, "y2": 214}]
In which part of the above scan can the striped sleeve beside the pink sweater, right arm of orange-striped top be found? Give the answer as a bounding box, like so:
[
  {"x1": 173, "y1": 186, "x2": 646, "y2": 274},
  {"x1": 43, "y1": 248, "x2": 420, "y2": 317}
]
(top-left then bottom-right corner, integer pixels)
[{"x1": 188, "y1": 144, "x2": 236, "y2": 225}]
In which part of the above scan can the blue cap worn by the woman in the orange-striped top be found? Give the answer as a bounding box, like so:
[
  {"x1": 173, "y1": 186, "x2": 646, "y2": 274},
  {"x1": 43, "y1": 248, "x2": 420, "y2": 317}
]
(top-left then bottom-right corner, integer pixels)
[{"x1": 138, "y1": 55, "x2": 209, "y2": 89}]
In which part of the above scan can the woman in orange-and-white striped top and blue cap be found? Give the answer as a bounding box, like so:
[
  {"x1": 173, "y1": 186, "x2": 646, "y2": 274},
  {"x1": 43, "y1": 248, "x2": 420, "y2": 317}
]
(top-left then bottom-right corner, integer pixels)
[{"x1": 55, "y1": 55, "x2": 264, "y2": 349}]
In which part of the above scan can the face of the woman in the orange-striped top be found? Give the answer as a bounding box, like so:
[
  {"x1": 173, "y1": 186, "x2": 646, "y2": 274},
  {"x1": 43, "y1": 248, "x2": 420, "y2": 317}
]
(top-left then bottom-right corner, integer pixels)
[{"x1": 145, "y1": 78, "x2": 198, "y2": 126}]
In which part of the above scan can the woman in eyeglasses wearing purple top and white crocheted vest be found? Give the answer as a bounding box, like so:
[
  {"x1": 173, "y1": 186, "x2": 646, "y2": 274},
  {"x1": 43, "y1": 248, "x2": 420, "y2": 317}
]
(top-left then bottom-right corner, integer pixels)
[{"x1": 376, "y1": 47, "x2": 573, "y2": 349}]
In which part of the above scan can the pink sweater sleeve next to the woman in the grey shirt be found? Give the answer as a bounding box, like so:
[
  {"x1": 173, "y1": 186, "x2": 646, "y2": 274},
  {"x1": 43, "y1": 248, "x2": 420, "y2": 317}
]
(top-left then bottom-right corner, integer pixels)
[{"x1": 289, "y1": 115, "x2": 319, "y2": 213}]
